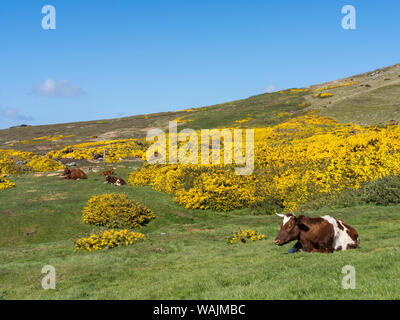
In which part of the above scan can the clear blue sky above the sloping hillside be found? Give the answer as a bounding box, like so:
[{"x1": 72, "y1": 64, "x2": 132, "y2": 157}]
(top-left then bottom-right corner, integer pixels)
[{"x1": 0, "y1": 0, "x2": 400, "y2": 128}]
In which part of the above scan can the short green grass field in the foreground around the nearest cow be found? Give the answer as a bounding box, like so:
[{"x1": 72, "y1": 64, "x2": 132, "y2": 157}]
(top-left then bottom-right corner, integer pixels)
[{"x1": 0, "y1": 163, "x2": 400, "y2": 299}]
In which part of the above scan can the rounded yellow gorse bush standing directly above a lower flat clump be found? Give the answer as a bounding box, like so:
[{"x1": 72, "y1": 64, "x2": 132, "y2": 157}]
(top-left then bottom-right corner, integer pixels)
[{"x1": 83, "y1": 193, "x2": 155, "y2": 228}]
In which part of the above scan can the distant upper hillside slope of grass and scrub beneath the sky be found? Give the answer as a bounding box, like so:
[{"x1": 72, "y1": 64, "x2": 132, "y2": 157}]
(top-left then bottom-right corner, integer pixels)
[{"x1": 0, "y1": 64, "x2": 400, "y2": 154}]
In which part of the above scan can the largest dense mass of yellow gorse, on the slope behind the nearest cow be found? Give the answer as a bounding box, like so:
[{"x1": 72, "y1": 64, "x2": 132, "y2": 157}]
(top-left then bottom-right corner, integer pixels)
[{"x1": 129, "y1": 113, "x2": 400, "y2": 211}]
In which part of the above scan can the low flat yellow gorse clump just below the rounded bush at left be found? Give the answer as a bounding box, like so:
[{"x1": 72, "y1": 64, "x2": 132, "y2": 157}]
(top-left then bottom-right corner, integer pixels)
[{"x1": 74, "y1": 229, "x2": 146, "y2": 251}]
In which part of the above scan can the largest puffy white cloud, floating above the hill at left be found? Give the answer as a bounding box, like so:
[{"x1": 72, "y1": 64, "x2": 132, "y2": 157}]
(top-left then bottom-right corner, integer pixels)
[{"x1": 33, "y1": 78, "x2": 85, "y2": 97}]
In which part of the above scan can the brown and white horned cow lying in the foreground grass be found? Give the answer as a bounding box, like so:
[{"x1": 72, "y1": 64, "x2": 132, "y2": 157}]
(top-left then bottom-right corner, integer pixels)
[{"x1": 274, "y1": 214, "x2": 360, "y2": 253}]
